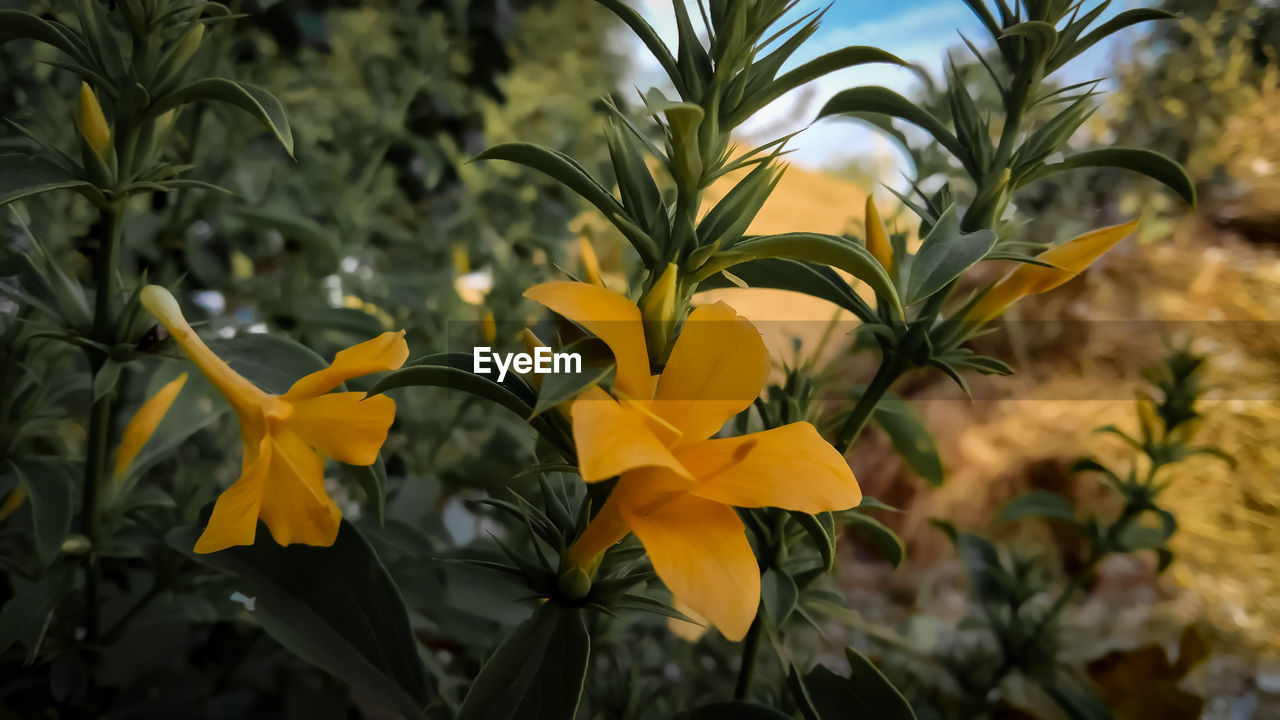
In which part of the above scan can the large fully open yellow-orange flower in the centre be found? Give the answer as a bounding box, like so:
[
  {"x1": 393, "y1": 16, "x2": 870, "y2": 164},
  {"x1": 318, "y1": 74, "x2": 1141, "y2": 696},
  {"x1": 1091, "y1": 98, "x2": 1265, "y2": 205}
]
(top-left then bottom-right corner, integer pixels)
[{"x1": 525, "y1": 282, "x2": 861, "y2": 641}]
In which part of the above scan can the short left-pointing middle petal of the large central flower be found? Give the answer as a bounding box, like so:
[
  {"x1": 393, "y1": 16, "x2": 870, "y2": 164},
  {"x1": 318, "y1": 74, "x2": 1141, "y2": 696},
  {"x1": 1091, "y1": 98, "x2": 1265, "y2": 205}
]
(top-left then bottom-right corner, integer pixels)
[{"x1": 570, "y1": 387, "x2": 689, "y2": 483}]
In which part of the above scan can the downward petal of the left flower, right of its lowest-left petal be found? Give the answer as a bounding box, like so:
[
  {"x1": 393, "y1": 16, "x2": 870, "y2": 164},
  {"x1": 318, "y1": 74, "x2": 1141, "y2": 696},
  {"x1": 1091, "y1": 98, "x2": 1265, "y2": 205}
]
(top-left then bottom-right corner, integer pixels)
[{"x1": 259, "y1": 430, "x2": 342, "y2": 546}]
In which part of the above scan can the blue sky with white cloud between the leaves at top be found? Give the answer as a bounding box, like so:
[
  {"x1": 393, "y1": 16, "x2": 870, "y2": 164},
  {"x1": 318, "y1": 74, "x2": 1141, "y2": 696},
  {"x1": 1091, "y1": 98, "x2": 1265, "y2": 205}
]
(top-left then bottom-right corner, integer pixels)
[{"x1": 630, "y1": 0, "x2": 1155, "y2": 169}]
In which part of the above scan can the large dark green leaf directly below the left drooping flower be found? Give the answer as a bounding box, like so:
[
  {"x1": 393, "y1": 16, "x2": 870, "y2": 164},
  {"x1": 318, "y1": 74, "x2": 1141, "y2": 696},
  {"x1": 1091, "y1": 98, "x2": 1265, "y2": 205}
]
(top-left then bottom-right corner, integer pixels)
[{"x1": 165, "y1": 520, "x2": 431, "y2": 717}]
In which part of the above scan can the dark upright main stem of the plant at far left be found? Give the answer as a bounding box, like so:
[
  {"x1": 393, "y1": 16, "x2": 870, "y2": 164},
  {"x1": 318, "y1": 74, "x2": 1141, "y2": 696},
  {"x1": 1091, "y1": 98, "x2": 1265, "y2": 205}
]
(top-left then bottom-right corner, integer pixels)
[{"x1": 81, "y1": 202, "x2": 124, "y2": 642}]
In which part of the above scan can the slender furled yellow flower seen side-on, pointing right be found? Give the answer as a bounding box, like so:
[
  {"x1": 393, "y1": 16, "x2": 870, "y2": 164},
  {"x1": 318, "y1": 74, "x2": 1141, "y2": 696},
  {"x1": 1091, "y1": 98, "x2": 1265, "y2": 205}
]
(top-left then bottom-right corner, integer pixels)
[{"x1": 965, "y1": 215, "x2": 1138, "y2": 323}]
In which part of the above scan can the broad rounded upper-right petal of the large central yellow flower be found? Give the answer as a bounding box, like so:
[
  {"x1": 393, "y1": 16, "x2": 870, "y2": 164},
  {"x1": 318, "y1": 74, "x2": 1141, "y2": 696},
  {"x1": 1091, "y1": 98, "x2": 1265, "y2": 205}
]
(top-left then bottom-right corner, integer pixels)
[{"x1": 652, "y1": 302, "x2": 769, "y2": 445}]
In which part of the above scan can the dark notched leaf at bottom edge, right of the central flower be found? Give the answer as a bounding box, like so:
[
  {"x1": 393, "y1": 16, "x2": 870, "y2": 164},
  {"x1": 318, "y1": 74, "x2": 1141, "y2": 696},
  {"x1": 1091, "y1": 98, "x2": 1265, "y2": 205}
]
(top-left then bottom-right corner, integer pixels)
[{"x1": 804, "y1": 647, "x2": 915, "y2": 720}]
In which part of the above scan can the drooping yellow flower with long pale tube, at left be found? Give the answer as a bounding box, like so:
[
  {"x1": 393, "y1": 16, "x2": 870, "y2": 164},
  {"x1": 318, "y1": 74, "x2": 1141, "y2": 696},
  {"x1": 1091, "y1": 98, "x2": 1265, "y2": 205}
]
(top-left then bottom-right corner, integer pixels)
[{"x1": 142, "y1": 286, "x2": 408, "y2": 552}]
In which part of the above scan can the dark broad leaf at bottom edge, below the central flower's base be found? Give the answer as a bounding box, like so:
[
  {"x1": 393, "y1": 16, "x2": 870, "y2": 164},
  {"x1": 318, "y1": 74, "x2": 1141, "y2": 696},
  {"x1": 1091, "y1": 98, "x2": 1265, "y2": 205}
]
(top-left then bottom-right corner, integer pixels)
[{"x1": 457, "y1": 602, "x2": 591, "y2": 720}]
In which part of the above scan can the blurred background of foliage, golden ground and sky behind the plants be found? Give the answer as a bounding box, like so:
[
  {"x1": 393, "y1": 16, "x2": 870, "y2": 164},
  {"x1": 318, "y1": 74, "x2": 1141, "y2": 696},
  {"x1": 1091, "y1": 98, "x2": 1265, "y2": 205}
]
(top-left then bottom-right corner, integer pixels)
[{"x1": 0, "y1": 0, "x2": 1280, "y2": 720}]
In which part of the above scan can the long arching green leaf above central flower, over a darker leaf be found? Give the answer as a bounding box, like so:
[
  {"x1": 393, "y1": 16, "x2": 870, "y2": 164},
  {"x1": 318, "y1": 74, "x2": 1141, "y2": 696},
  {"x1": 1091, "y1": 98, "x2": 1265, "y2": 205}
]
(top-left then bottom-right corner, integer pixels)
[{"x1": 716, "y1": 232, "x2": 902, "y2": 318}]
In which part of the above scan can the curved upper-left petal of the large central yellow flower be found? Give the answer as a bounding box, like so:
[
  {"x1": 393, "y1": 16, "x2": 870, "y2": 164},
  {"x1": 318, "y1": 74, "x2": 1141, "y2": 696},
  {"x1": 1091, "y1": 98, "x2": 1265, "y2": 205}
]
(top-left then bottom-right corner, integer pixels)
[{"x1": 525, "y1": 282, "x2": 653, "y2": 400}]
